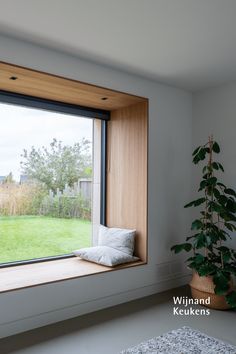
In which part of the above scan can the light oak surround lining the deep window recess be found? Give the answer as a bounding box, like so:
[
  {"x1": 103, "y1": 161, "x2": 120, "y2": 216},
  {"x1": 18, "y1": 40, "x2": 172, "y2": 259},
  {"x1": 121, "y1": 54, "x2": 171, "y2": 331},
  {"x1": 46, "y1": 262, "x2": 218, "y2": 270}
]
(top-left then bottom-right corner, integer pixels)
[{"x1": 0, "y1": 62, "x2": 148, "y2": 292}]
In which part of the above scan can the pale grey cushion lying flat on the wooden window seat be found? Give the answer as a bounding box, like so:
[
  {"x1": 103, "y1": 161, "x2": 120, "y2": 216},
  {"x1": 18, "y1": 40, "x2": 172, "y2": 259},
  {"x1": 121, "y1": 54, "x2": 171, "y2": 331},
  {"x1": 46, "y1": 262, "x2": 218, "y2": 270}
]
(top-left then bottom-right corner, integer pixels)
[{"x1": 73, "y1": 246, "x2": 139, "y2": 267}]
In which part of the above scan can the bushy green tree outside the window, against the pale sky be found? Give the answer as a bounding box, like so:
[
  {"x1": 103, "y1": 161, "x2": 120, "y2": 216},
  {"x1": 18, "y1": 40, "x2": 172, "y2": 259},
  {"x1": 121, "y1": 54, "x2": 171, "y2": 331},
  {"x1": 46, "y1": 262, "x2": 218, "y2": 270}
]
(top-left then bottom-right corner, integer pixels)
[{"x1": 21, "y1": 138, "x2": 92, "y2": 192}]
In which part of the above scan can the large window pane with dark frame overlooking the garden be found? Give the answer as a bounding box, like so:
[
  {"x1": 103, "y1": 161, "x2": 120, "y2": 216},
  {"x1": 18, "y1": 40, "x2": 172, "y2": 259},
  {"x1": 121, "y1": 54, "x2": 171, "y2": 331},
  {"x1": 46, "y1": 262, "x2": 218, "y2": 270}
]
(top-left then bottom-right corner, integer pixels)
[{"x1": 0, "y1": 92, "x2": 109, "y2": 266}]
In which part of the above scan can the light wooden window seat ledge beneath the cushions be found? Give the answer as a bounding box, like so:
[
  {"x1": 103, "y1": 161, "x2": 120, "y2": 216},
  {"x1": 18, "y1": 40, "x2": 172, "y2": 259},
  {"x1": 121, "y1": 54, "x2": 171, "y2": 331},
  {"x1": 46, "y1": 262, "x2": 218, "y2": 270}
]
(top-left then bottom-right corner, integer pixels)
[{"x1": 0, "y1": 257, "x2": 146, "y2": 293}]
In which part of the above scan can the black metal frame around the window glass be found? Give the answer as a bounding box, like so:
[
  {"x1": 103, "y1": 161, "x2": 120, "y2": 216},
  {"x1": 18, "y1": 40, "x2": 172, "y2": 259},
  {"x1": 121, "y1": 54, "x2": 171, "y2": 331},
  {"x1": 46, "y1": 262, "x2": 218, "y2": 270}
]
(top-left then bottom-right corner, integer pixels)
[{"x1": 0, "y1": 90, "x2": 110, "y2": 268}]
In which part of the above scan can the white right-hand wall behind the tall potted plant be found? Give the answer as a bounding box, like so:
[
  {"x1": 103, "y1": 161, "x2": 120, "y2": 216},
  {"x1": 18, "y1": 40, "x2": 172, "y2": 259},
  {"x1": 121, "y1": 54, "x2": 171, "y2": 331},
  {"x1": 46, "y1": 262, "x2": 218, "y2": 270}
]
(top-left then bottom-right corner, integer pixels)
[{"x1": 193, "y1": 82, "x2": 236, "y2": 248}]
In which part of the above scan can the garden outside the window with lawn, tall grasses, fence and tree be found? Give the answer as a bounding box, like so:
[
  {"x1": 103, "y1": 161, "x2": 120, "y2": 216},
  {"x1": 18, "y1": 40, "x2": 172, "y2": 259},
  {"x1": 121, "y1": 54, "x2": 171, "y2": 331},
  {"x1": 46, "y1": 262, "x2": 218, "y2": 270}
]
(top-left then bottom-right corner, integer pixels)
[{"x1": 0, "y1": 139, "x2": 92, "y2": 263}]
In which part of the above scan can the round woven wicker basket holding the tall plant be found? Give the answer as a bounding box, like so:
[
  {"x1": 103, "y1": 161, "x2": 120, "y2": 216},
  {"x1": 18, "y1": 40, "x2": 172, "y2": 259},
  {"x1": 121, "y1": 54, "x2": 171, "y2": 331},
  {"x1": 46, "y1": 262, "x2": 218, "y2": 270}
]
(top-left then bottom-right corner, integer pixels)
[{"x1": 189, "y1": 272, "x2": 233, "y2": 310}]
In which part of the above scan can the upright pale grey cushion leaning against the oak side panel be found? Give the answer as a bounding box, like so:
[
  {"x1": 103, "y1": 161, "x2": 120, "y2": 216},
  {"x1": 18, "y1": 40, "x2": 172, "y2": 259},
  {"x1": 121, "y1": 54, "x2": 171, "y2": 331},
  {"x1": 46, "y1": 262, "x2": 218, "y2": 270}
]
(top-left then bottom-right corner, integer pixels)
[{"x1": 98, "y1": 225, "x2": 135, "y2": 256}]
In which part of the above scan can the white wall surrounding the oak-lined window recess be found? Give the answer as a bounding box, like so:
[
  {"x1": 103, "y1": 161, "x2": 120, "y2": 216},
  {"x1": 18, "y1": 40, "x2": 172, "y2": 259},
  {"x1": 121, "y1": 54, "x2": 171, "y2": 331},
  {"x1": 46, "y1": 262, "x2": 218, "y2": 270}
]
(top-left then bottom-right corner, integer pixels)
[{"x1": 0, "y1": 37, "x2": 192, "y2": 337}]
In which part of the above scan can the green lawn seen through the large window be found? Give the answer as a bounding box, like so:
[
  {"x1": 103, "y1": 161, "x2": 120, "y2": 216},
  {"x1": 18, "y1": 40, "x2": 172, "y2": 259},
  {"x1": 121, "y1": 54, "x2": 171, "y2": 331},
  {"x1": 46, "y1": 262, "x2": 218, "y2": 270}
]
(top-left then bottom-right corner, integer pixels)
[{"x1": 0, "y1": 216, "x2": 91, "y2": 263}]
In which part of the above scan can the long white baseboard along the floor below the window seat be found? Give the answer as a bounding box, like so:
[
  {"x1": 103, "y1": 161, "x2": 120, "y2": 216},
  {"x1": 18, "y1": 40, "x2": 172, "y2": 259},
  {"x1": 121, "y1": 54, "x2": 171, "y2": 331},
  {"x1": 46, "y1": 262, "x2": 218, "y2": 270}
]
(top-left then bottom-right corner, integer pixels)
[{"x1": 0, "y1": 275, "x2": 190, "y2": 338}]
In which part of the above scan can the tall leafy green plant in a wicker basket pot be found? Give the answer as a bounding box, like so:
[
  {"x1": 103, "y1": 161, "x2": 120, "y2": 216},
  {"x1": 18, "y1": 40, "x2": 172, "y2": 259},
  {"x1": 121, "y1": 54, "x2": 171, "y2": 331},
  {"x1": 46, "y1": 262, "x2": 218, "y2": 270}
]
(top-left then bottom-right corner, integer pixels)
[{"x1": 171, "y1": 136, "x2": 236, "y2": 309}]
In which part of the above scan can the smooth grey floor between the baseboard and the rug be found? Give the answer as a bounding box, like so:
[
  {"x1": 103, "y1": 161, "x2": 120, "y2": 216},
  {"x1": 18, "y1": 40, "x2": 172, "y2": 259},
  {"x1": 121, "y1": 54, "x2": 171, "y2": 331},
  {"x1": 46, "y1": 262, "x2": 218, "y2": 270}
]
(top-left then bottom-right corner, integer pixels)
[{"x1": 0, "y1": 288, "x2": 236, "y2": 354}]
